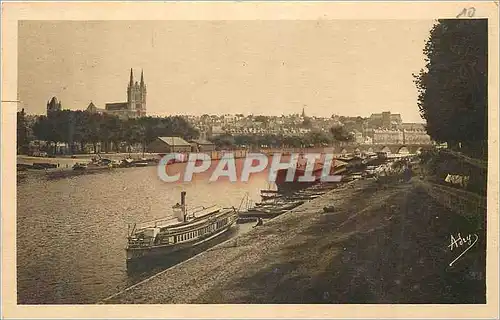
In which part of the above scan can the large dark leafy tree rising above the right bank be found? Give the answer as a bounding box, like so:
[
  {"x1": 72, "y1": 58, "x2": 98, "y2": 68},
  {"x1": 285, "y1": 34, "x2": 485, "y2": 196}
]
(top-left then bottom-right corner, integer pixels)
[{"x1": 414, "y1": 19, "x2": 488, "y2": 156}]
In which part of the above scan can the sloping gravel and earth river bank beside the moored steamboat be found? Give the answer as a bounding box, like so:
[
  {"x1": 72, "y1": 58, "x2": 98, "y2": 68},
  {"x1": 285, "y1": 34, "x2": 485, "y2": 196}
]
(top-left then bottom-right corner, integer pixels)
[{"x1": 100, "y1": 180, "x2": 486, "y2": 304}]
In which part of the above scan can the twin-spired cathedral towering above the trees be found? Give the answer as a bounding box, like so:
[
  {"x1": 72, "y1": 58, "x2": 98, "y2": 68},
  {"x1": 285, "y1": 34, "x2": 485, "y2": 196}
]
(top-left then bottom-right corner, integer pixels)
[{"x1": 104, "y1": 69, "x2": 147, "y2": 119}]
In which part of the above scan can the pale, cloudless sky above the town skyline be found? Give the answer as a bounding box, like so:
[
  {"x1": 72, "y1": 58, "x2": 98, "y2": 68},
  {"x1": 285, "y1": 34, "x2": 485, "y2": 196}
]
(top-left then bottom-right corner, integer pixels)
[{"x1": 18, "y1": 20, "x2": 433, "y2": 122}]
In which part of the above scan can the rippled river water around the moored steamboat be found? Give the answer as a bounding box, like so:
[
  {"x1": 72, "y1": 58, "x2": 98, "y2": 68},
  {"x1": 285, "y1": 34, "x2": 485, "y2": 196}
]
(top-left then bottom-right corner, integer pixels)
[{"x1": 17, "y1": 164, "x2": 269, "y2": 304}]
